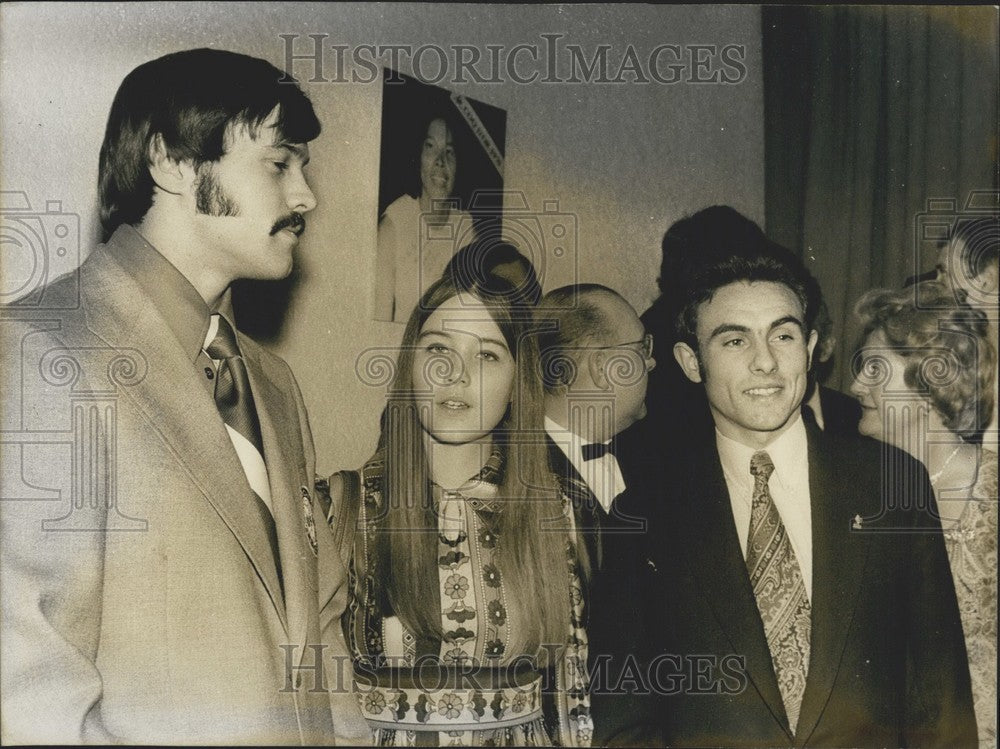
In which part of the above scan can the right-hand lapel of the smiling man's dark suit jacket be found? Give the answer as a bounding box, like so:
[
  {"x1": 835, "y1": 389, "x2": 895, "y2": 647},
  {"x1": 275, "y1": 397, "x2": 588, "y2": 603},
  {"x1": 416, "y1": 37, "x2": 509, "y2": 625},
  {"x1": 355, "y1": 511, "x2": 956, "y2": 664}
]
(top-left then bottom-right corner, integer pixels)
[{"x1": 796, "y1": 427, "x2": 878, "y2": 745}]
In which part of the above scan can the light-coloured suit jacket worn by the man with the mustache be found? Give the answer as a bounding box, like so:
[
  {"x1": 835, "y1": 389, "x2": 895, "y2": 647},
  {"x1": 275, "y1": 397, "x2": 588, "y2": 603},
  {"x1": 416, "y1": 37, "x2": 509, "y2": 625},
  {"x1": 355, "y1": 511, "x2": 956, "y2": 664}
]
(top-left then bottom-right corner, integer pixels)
[{"x1": 0, "y1": 227, "x2": 370, "y2": 744}]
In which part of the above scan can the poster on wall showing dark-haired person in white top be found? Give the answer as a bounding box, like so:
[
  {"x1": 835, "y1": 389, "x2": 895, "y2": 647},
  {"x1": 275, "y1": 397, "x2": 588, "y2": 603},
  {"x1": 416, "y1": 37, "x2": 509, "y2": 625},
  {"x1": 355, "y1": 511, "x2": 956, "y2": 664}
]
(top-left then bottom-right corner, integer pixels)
[{"x1": 374, "y1": 68, "x2": 507, "y2": 323}]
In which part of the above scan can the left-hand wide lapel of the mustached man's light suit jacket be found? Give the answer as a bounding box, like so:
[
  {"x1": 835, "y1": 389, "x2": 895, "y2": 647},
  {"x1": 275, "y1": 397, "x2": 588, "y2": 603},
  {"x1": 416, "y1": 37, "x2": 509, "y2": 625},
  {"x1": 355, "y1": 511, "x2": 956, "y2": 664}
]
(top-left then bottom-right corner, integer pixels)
[{"x1": 81, "y1": 252, "x2": 287, "y2": 627}]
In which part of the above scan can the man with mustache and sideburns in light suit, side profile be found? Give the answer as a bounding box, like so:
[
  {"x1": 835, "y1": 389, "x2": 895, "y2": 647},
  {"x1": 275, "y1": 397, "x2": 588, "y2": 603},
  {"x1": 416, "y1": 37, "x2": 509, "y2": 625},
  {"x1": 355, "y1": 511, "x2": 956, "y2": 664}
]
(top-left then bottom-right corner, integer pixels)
[{"x1": 0, "y1": 49, "x2": 370, "y2": 744}]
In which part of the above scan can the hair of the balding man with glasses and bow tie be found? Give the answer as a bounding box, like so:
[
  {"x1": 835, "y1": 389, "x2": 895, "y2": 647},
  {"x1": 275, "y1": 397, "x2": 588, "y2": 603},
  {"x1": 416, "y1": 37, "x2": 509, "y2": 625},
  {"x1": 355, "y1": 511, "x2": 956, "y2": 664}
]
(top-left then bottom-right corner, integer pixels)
[{"x1": 535, "y1": 283, "x2": 621, "y2": 392}]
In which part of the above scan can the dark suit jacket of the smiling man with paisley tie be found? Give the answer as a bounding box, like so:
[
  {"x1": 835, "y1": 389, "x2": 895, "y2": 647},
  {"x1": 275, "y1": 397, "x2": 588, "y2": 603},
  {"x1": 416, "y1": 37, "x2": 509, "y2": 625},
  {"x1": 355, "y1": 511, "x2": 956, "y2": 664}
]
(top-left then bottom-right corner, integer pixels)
[{"x1": 591, "y1": 426, "x2": 976, "y2": 747}]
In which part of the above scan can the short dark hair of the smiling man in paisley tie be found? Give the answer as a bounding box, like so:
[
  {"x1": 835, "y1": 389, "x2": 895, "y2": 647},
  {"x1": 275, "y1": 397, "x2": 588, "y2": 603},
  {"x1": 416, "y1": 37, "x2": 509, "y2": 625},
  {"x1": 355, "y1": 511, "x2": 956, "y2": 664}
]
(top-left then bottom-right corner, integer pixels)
[{"x1": 675, "y1": 248, "x2": 820, "y2": 351}]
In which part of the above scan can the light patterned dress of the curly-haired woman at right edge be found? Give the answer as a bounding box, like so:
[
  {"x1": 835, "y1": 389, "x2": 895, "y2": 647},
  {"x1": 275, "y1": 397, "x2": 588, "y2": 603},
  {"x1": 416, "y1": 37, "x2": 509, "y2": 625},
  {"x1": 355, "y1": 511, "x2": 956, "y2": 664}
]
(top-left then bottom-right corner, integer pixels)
[{"x1": 945, "y1": 451, "x2": 997, "y2": 749}]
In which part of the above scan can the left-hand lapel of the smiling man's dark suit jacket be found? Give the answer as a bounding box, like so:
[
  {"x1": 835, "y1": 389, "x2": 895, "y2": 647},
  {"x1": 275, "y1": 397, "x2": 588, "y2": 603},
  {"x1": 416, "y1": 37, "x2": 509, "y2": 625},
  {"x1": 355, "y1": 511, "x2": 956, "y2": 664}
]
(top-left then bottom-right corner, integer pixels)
[{"x1": 675, "y1": 436, "x2": 791, "y2": 740}]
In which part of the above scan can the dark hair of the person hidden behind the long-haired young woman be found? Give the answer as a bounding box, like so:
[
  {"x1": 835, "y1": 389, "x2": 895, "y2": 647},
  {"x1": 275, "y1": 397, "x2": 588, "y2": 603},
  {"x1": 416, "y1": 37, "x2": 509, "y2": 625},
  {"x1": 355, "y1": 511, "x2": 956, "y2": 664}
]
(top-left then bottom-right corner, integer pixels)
[{"x1": 441, "y1": 235, "x2": 542, "y2": 306}]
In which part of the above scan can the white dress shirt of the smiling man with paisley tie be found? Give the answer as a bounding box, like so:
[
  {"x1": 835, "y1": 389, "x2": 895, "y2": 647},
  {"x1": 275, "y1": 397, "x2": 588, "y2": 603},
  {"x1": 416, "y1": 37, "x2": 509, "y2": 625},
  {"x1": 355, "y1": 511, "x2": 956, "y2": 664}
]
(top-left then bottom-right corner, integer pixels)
[{"x1": 715, "y1": 415, "x2": 812, "y2": 601}]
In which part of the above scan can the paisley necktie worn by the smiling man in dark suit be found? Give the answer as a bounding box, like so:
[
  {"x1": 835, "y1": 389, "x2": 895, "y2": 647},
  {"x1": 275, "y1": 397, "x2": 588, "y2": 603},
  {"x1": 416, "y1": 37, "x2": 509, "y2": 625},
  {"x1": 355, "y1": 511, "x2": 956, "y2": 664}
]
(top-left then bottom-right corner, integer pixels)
[{"x1": 747, "y1": 450, "x2": 812, "y2": 733}]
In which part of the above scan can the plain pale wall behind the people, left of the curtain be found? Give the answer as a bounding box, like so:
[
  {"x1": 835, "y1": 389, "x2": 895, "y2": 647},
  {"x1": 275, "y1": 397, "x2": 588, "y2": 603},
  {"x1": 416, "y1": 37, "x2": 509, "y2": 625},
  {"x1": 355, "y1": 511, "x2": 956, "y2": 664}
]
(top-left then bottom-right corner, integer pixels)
[{"x1": 0, "y1": 3, "x2": 764, "y2": 470}]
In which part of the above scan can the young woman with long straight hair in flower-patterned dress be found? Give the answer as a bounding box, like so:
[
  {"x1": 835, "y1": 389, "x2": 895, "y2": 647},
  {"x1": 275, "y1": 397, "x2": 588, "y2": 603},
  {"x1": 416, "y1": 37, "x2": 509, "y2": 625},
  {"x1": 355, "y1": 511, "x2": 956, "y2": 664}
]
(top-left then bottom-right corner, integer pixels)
[{"x1": 320, "y1": 276, "x2": 592, "y2": 746}]
